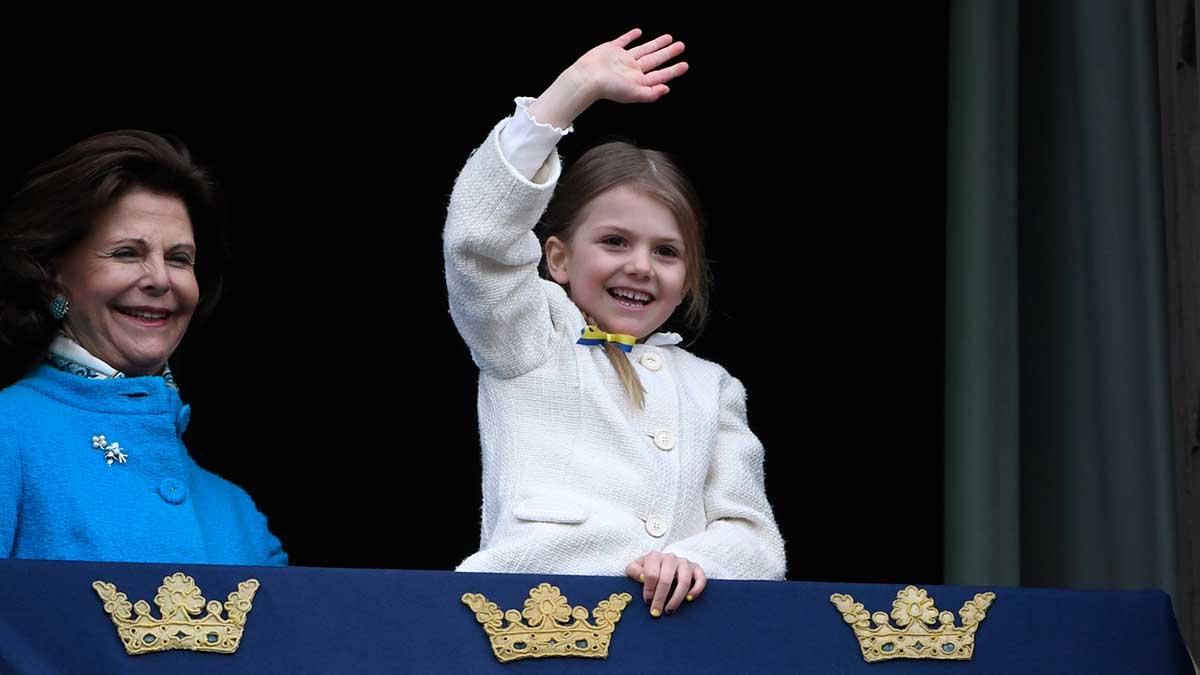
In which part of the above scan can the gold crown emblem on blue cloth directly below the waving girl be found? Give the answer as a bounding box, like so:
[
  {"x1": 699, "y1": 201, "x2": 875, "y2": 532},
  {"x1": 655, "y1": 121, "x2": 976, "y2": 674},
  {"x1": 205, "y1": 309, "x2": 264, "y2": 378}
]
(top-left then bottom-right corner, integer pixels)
[{"x1": 462, "y1": 584, "x2": 634, "y2": 663}]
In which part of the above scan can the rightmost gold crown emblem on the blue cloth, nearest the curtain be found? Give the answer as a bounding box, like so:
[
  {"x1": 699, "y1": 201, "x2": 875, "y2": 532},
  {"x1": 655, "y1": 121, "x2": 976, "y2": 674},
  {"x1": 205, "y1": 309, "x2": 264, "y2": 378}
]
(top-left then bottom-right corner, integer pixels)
[{"x1": 829, "y1": 586, "x2": 996, "y2": 662}]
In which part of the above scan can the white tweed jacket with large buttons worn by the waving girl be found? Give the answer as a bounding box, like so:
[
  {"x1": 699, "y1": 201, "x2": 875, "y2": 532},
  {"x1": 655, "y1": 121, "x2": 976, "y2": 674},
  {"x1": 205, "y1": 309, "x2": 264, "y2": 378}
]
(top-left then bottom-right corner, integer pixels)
[{"x1": 443, "y1": 120, "x2": 785, "y2": 579}]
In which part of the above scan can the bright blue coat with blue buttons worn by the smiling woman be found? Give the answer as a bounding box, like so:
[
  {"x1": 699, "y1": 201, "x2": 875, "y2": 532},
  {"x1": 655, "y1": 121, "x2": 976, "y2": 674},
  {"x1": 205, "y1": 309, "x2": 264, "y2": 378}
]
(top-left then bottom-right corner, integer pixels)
[{"x1": 0, "y1": 365, "x2": 288, "y2": 565}]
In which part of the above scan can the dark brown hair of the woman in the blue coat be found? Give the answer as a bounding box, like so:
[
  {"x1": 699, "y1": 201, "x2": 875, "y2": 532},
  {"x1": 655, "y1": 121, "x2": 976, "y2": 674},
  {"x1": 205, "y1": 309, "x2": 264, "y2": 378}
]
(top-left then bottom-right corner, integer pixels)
[{"x1": 0, "y1": 131, "x2": 228, "y2": 388}]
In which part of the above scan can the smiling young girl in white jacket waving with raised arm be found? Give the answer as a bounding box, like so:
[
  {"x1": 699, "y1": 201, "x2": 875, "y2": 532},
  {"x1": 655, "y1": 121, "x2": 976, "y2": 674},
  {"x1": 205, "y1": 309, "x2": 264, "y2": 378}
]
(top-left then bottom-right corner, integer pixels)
[{"x1": 444, "y1": 30, "x2": 785, "y2": 616}]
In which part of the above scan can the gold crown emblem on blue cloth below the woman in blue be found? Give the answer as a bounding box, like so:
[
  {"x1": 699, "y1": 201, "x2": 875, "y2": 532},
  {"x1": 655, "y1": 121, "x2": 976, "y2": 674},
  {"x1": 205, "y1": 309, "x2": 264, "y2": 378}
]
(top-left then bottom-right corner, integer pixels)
[{"x1": 91, "y1": 572, "x2": 258, "y2": 655}]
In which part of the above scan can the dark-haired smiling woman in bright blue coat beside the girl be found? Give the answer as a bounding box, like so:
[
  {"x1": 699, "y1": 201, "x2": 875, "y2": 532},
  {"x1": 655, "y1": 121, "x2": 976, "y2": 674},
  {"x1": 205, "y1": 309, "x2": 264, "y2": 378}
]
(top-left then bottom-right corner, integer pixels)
[{"x1": 0, "y1": 131, "x2": 287, "y2": 565}]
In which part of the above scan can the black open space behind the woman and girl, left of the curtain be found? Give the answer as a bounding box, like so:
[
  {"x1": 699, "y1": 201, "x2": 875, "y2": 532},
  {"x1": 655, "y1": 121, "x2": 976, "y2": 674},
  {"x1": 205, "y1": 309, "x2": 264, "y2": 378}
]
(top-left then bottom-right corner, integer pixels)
[{"x1": 0, "y1": 13, "x2": 947, "y2": 584}]
